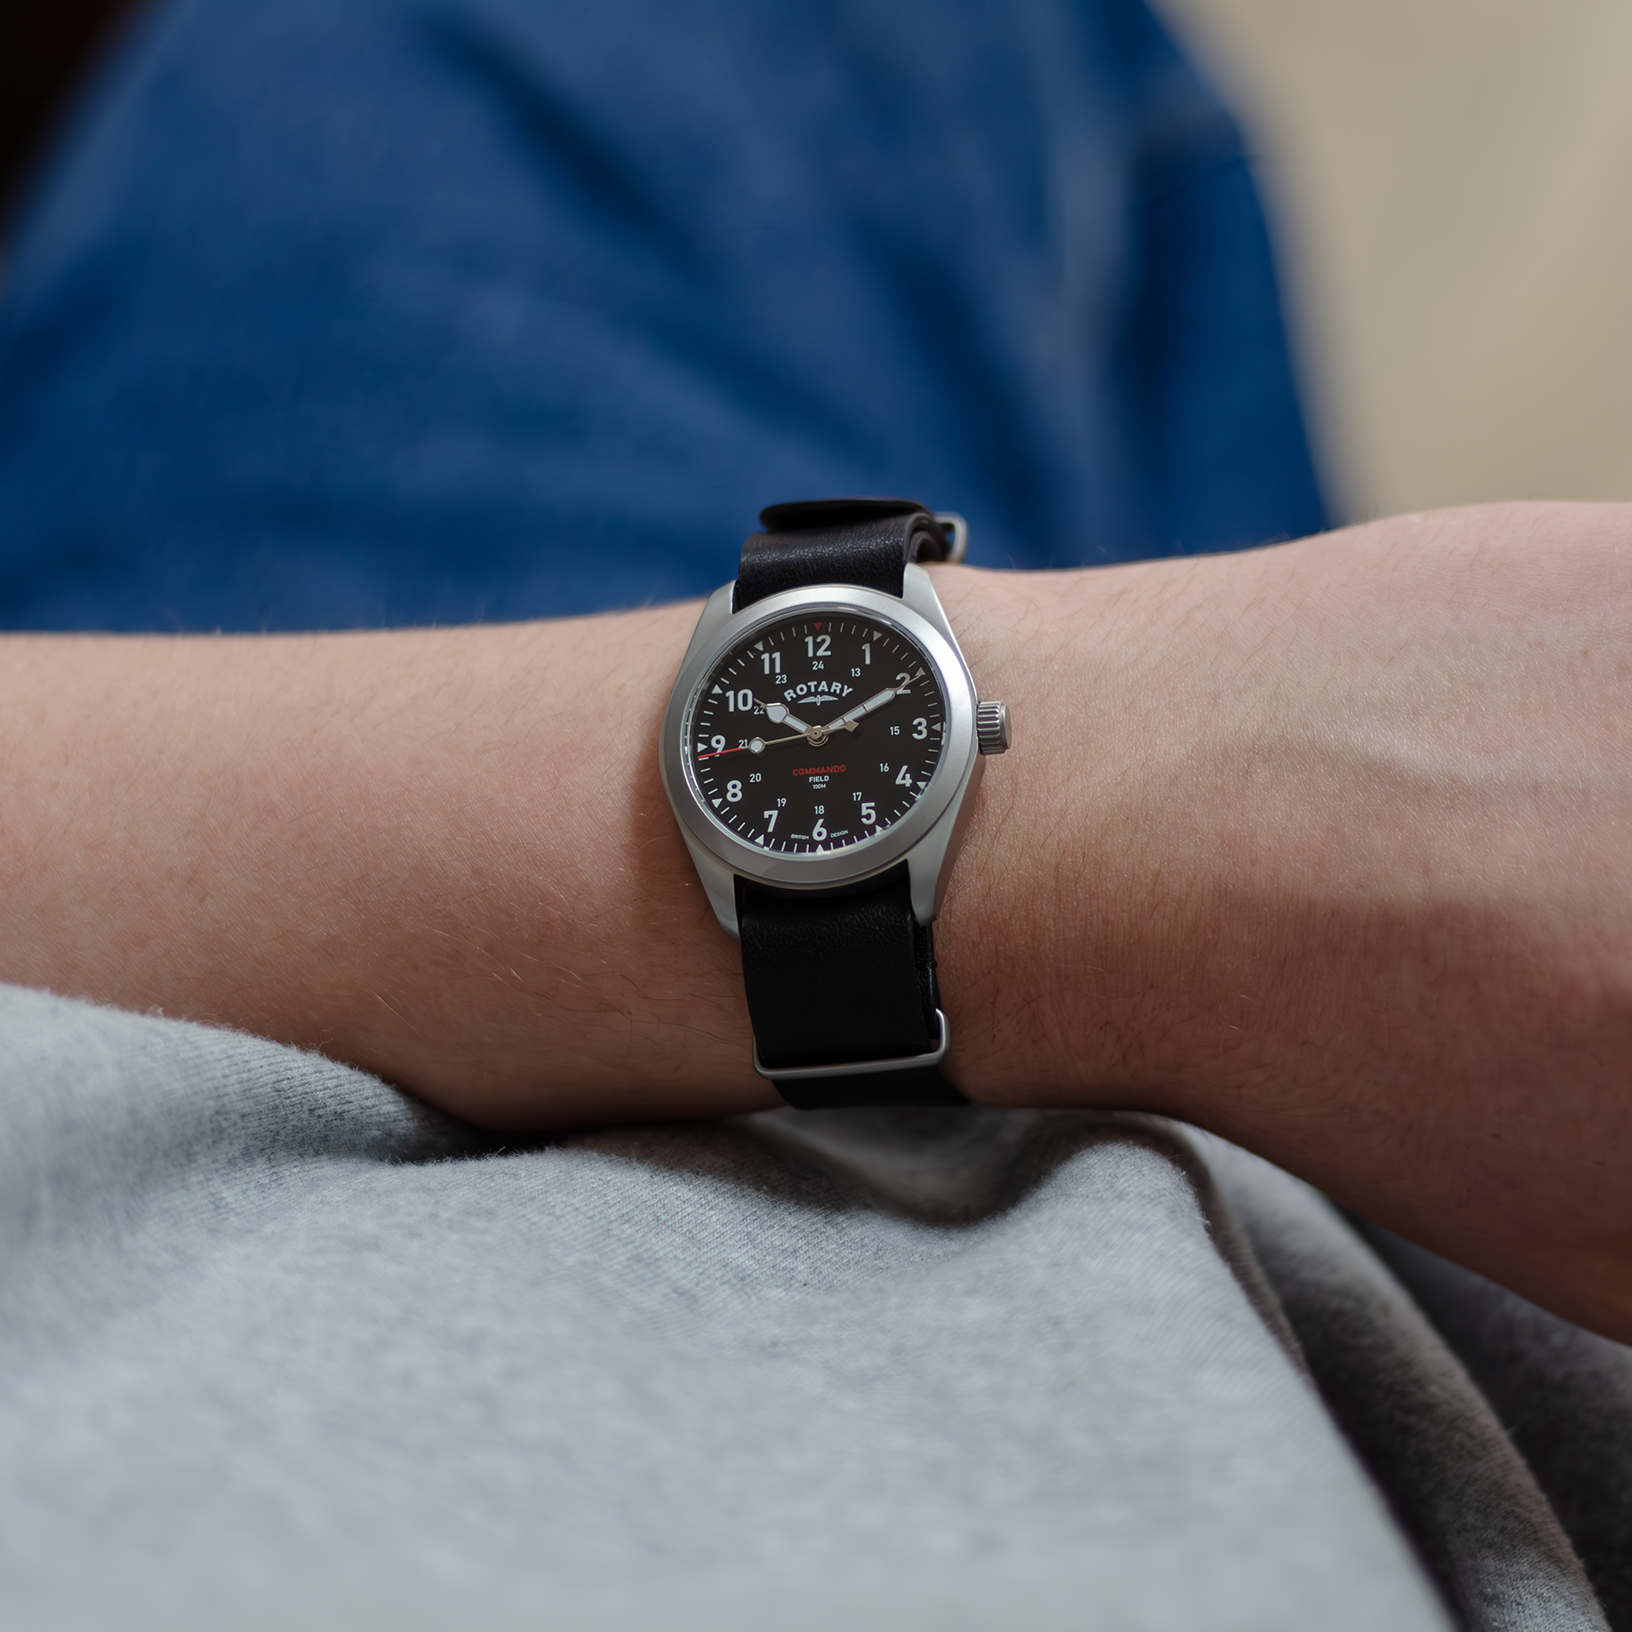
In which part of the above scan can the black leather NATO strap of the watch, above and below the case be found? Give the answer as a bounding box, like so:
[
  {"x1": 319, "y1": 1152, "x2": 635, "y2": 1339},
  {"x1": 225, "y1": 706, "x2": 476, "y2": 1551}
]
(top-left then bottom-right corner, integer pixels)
[{"x1": 734, "y1": 499, "x2": 968, "y2": 1110}]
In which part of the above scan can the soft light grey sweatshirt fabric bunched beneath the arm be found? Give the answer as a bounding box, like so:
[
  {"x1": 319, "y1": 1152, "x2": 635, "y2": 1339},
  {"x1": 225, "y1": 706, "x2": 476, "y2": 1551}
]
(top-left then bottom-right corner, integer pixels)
[{"x1": 0, "y1": 987, "x2": 1612, "y2": 1632}]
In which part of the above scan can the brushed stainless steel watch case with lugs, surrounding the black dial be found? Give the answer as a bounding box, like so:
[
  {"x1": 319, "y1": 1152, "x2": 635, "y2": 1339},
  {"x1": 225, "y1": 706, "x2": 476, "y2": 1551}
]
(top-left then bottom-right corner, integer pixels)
[{"x1": 658, "y1": 566, "x2": 982, "y2": 937}]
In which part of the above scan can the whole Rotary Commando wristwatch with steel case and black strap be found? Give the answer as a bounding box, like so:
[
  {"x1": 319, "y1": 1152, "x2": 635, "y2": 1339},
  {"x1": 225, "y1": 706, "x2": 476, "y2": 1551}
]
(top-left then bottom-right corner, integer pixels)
[{"x1": 661, "y1": 499, "x2": 1009, "y2": 1110}]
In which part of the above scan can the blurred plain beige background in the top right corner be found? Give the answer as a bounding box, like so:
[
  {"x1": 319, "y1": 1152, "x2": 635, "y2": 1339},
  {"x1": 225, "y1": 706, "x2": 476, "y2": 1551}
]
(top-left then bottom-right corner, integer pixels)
[{"x1": 1157, "y1": 0, "x2": 1632, "y2": 516}]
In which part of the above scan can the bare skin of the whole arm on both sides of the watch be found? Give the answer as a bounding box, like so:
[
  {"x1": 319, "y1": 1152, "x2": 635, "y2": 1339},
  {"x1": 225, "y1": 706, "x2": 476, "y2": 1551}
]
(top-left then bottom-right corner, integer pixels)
[{"x1": 0, "y1": 504, "x2": 1632, "y2": 1340}]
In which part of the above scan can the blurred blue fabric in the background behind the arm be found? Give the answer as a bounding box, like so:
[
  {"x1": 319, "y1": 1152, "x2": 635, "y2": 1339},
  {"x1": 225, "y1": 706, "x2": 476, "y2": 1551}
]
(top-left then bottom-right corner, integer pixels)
[{"x1": 0, "y1": 0, "x2": 1324, "y2": 630}]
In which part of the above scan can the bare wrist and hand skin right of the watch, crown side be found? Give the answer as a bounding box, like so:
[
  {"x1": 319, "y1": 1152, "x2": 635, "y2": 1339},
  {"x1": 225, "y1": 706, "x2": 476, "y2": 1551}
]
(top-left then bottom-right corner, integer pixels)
[{"x1": 942, "y1": 506, "x2": 1632, "y2": 1335}]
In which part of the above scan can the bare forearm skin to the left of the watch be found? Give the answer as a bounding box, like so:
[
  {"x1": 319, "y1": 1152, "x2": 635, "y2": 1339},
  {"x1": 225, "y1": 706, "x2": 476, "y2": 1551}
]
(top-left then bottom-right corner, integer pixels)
[{"x1": 0, "y1": 607, "x2": 774, "y2": 1126}]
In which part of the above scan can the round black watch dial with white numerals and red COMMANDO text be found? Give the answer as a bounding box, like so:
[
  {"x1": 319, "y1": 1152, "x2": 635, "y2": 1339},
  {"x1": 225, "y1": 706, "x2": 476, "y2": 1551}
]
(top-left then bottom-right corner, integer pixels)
[{"x1": 687, "y1": 614, "x2": 947, "y2": 855}]
